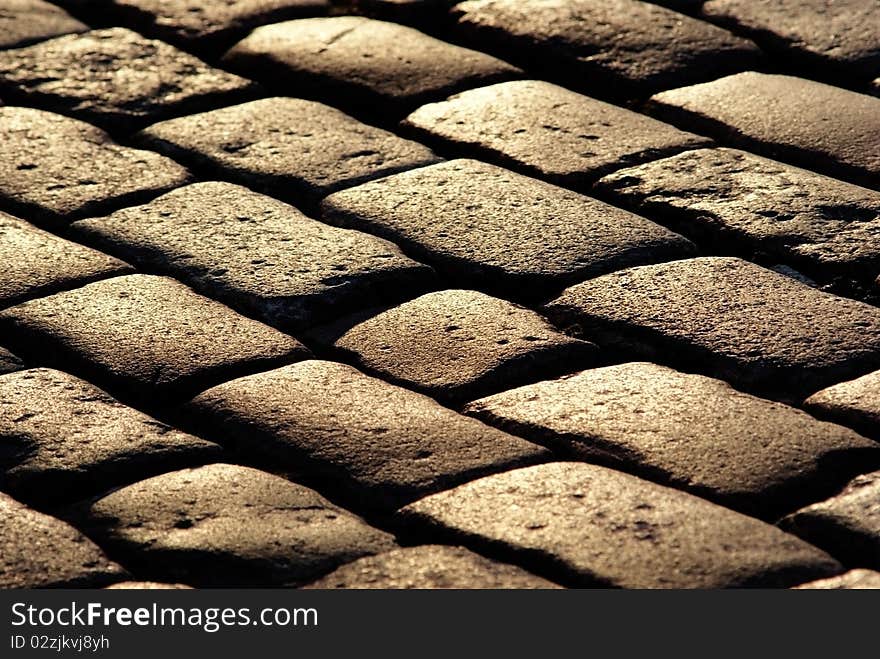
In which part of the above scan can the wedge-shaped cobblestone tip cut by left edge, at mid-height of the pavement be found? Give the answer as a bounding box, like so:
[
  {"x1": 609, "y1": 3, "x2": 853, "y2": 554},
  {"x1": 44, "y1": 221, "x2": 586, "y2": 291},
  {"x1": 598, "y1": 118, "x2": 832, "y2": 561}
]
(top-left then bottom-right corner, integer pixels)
[{"x1": 0, "y1": 211, "x2": 132, "y2": 307}]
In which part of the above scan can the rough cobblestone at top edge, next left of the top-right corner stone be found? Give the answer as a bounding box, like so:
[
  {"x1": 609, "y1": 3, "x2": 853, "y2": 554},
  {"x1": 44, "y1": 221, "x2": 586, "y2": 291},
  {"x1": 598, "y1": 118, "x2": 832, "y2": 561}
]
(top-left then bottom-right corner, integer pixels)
[{"x1": 453, "y1": 0, "x2": 760, "y2": 95}]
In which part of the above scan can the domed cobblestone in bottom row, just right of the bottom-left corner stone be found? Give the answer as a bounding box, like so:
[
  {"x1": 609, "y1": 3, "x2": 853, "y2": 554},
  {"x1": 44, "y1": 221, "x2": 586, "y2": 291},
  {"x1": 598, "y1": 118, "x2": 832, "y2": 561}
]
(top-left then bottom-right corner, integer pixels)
[{"x1": 83, "y1": 464, "x2": 395, "y2": 586}]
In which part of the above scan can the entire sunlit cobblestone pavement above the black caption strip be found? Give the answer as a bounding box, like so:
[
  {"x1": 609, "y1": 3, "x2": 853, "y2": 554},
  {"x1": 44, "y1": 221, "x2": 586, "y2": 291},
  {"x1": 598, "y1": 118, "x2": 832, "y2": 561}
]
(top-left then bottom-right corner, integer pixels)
[{"x1": 0, "y1": 0, "x2": 880, "y2": 589}]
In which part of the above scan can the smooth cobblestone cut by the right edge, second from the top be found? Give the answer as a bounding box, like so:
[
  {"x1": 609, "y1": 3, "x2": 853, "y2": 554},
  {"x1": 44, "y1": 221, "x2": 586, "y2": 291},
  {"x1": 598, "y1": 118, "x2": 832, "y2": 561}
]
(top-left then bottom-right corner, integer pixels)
[{"x1": 649, "y1": 71, "x2": 880, "y2": 187}]
